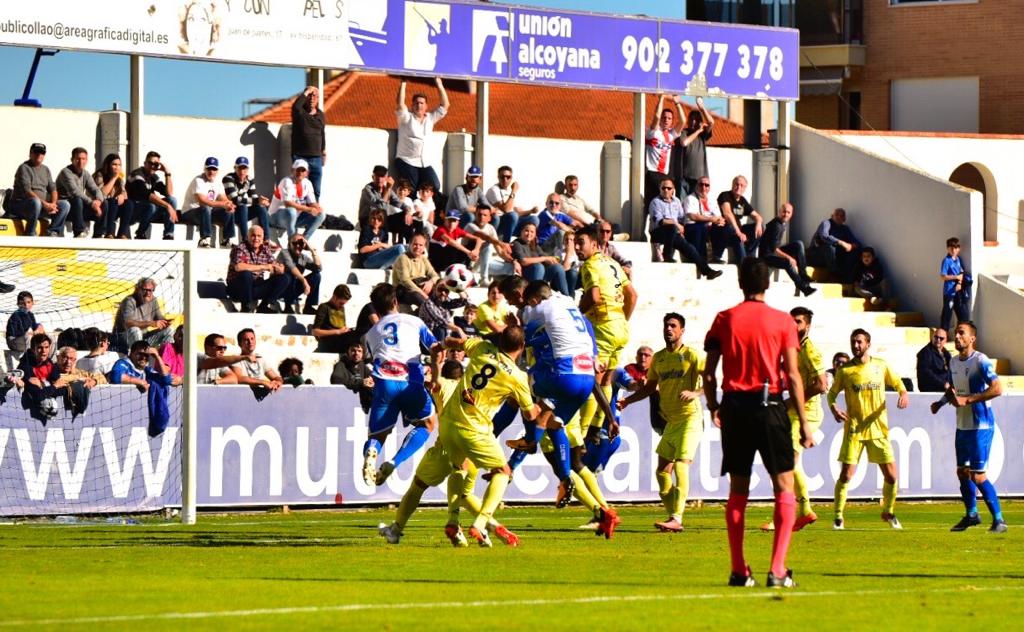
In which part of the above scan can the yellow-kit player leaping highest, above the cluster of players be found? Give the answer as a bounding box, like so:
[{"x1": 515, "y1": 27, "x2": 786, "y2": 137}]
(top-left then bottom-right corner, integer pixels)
[{"x1": 575, "y1": 222, "x2": 637, "y2": 444}]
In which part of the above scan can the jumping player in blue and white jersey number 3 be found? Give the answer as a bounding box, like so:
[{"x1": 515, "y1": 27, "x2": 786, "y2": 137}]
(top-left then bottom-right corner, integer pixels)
[{"x1": 362, "y1": 283, "x2": 437, "y2": 486}]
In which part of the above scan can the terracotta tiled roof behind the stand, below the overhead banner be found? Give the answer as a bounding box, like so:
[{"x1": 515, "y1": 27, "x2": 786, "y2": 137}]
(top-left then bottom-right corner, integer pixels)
[{"x1": 252, "y1": 71, "x2": 743, "y2": 146}]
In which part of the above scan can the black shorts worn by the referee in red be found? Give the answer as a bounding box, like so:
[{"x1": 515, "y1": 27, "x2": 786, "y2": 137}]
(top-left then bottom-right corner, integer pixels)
[{"x1": 718, "y1": 392, "x2": 794, "y2": 476}]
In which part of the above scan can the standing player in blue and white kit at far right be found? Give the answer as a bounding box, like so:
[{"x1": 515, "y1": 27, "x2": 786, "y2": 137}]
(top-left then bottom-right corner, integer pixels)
[{"x1": 932, "y1": 321, "x2": 1007, "y2": 534}]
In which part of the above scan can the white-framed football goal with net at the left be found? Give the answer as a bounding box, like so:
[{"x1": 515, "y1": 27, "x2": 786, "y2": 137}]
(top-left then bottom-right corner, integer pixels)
[{"x1": 0, "y1": 237, "x2": 200, "y2": 524}]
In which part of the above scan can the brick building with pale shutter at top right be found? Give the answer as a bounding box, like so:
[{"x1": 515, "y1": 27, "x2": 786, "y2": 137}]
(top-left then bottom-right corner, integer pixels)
[{"x1": 797, "y1": 0, "x2": 1024, "y2": 134}]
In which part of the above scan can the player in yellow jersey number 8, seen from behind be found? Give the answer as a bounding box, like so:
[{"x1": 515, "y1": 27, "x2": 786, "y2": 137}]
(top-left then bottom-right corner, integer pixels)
[{"x1": 438, "y1": 326, "x2": 540, "y2": 547}]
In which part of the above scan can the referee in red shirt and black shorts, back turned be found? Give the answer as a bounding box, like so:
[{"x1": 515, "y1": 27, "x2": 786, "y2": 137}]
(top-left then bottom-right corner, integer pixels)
[{"x1": 703, "y1": 257, "x2": 814, "y2": 588}]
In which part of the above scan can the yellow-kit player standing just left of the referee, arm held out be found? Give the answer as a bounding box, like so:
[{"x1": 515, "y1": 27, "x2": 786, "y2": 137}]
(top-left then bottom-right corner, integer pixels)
[{"x1": 618, "y1": 311, "x2": 703, "y2": 533}]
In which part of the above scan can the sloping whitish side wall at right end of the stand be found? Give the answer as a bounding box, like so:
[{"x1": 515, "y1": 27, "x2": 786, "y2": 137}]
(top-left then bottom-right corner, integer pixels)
[{"x1": 791, "y1": 124, "x2": 982, "y2": 326}]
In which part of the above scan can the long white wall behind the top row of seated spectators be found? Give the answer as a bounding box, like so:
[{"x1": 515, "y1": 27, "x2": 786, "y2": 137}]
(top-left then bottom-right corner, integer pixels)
[{"x1": 0, "y1": 107, "x2": 754, "y2": 234}]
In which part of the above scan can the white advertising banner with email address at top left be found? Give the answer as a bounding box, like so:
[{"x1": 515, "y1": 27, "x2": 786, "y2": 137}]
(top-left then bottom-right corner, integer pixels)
[{"x1": 0, "y1": 0, "x2": 348, "y2": 69}]
